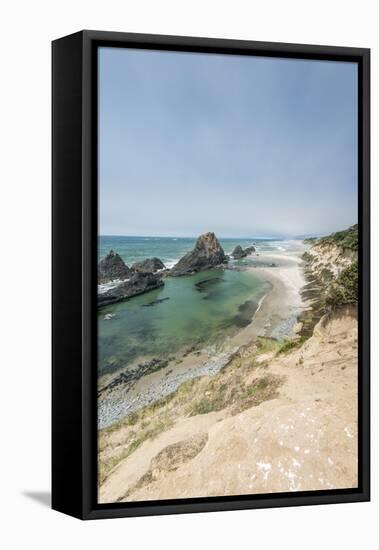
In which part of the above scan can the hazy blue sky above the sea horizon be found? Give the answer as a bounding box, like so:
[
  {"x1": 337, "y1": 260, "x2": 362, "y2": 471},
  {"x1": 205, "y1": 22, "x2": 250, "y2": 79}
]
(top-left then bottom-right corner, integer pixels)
[{"x1": 99, "y1": 48, "x2": 357, "y2": 237}]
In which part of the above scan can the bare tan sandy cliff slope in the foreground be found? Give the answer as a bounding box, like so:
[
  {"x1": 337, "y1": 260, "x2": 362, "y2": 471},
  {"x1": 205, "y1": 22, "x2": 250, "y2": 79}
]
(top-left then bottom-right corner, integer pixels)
[{"x1": 100, "y1": 308, "x2": 357, "y2": 502}]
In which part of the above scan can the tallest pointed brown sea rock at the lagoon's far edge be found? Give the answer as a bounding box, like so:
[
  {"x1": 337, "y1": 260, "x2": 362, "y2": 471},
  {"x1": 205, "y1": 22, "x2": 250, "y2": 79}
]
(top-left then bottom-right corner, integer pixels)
[{"x1": 170, "y1": 233, "x2": 228, "y2": 277}]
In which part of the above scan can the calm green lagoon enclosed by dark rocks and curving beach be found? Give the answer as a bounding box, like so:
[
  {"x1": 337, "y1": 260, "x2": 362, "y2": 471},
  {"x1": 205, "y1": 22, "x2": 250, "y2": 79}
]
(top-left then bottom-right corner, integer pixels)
[{"x1": 98, "y1": 269, "x2": 267, "y2": 375}]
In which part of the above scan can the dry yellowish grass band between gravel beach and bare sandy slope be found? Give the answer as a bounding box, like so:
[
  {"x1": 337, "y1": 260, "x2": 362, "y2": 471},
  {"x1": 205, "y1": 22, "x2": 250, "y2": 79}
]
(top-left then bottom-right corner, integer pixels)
[{"x1": 99, "y1": 338, "x2": 283, "y2": 484}]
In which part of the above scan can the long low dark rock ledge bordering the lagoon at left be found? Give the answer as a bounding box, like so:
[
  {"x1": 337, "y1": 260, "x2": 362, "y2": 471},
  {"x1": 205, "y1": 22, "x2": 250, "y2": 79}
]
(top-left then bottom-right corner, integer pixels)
[{"x1": 97, "y1": 272, "x2": 164, "y2": 307}]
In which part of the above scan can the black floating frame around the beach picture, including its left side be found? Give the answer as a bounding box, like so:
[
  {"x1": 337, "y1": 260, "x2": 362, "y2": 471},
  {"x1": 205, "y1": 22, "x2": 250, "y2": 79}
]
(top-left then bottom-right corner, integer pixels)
[{"x1": 52, "y1": 30, "x2": 370, "y2": 519}]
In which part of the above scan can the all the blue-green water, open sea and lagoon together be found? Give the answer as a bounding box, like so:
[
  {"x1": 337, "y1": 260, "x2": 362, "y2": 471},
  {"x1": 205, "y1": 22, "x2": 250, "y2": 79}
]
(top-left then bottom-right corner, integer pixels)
[{"x1": 98, "y1": 237, "x2": 298, "y2": 376}]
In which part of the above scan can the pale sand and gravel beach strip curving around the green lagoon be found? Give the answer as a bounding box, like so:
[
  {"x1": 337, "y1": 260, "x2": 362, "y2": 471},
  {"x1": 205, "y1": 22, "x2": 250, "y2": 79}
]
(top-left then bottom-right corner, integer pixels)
[{"x1": 98, "y1": 247, "x2": 306, "y2": 429}]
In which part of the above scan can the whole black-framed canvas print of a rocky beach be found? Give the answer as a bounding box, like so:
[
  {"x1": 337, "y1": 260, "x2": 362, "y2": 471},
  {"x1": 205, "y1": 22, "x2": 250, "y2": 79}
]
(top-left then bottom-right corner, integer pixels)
[{"x1": 52, "y1": 31, "x2": 370, "y2": 519}]
